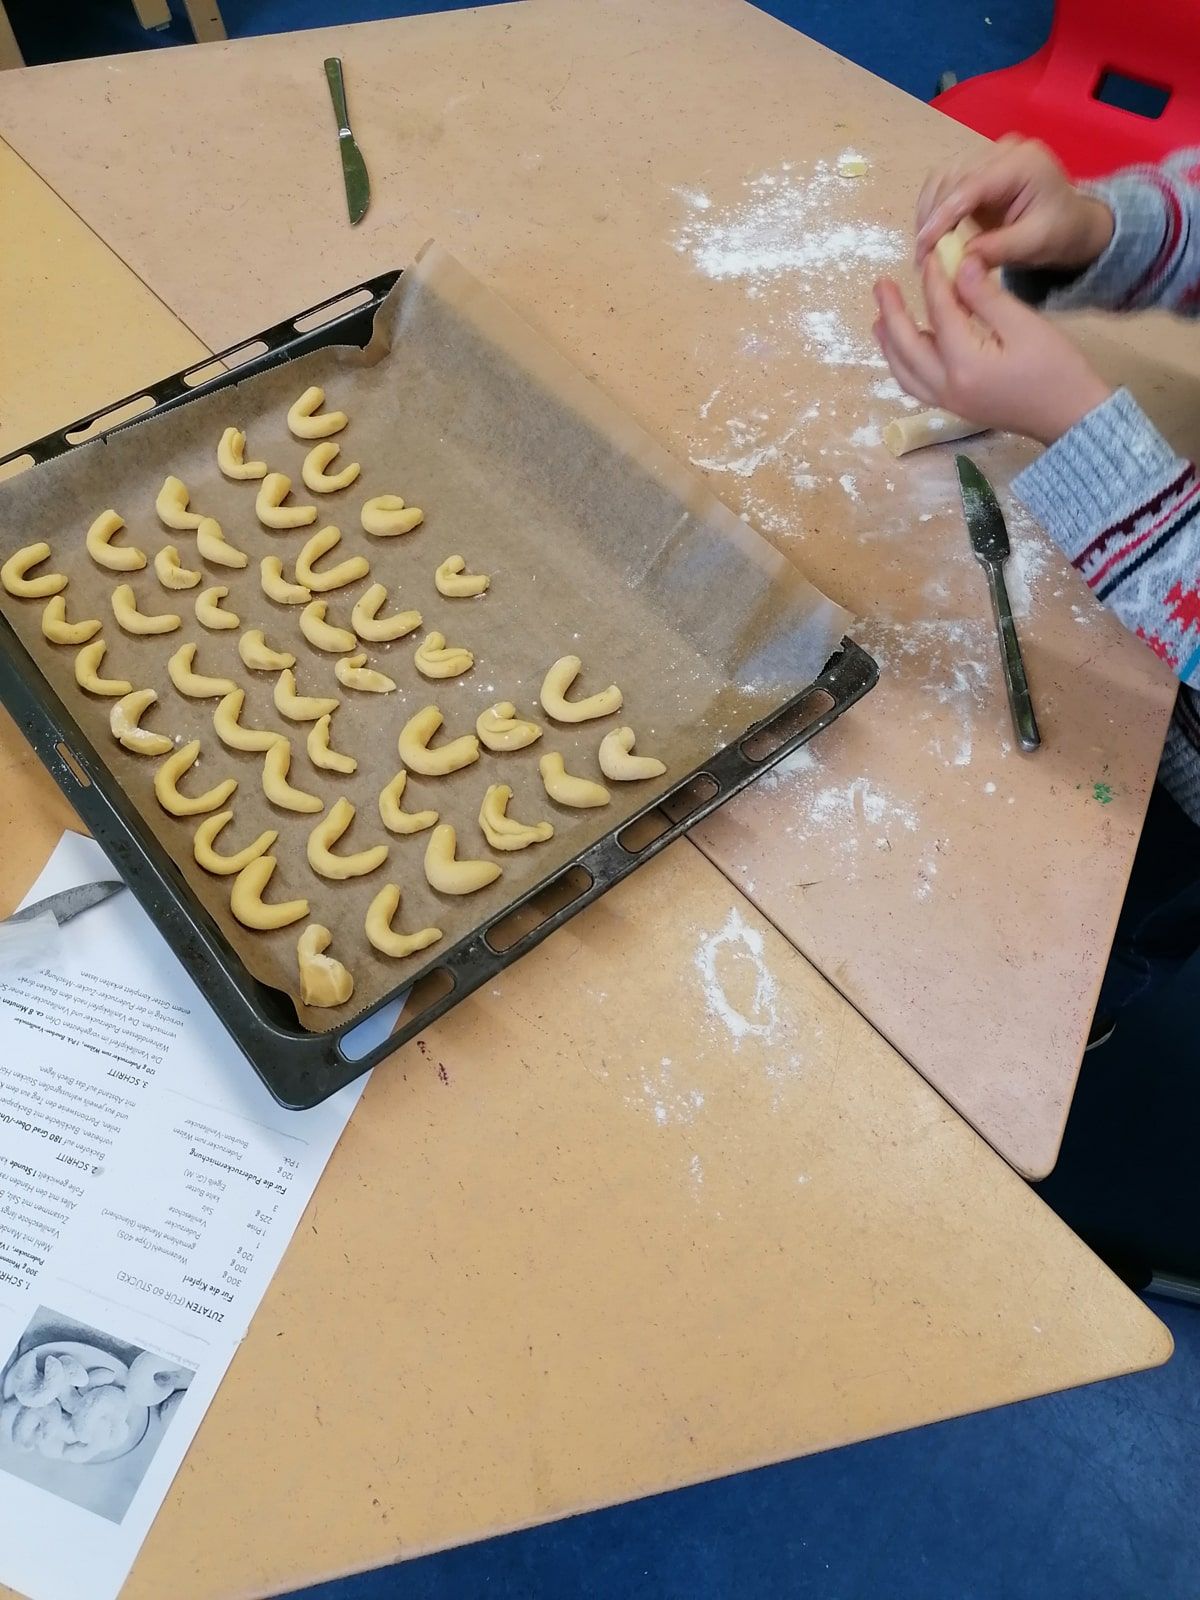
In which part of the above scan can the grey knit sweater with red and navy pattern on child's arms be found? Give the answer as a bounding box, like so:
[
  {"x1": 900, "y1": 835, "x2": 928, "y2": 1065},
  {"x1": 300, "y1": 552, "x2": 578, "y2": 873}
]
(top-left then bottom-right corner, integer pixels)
[{"x1": 1006, "y1": 150, "x2": 1200, "y2": 824}]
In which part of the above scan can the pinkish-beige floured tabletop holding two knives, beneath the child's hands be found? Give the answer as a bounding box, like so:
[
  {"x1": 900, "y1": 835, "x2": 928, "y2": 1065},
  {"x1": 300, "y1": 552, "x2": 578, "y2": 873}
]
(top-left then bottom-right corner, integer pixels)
[{"x1": 0, "y1": 0, "x2": 1200, "y2": 1176}]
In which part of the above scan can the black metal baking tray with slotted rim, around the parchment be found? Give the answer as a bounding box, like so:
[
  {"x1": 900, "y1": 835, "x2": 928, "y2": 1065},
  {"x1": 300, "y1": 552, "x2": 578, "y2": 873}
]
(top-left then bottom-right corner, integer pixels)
[{"x1": 0, "y1": 272, "x2": 878, "y2": 1109}]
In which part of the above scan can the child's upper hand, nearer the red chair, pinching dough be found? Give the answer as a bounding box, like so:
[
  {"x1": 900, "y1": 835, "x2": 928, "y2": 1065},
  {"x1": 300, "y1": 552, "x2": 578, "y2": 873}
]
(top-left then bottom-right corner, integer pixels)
[{"x1": 917, "y1": 136, "x2": 1114, "y2": 267}]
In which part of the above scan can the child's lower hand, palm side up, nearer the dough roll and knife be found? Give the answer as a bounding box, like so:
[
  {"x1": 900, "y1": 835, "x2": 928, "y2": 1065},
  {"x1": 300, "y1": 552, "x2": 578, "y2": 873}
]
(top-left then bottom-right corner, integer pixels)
[{"x1": 874, "y1": 254, "x2": 1112, "y2": 445}]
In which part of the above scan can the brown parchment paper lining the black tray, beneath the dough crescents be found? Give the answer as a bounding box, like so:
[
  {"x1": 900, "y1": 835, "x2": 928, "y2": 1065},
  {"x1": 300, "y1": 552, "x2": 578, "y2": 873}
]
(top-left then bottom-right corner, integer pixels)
[{"x1": 0, "y1": 245, "x2": 848, "y2": 1030}]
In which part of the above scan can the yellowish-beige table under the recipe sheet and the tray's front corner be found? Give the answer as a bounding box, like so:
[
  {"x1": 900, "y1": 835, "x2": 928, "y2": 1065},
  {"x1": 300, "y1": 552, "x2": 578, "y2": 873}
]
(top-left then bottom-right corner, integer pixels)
[{"x1": 0, "y1": 144, "x2": 1170, "y2": 1600}]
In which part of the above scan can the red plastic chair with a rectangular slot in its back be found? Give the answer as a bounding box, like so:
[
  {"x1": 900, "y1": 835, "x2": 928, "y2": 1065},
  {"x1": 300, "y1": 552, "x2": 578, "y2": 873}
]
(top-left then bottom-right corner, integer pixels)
[{"x1": 933, "y1": 0, "x2": 1200, "y2": 178}]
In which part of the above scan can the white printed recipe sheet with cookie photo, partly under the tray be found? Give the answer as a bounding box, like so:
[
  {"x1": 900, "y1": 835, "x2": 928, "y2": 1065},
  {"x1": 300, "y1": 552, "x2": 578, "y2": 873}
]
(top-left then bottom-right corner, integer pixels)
[{"x1": 0, "y1": 834, "x2": 365, "y2": 1600}]
